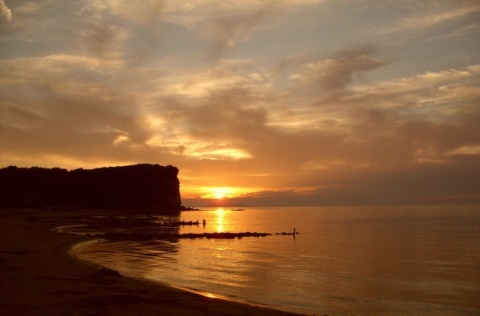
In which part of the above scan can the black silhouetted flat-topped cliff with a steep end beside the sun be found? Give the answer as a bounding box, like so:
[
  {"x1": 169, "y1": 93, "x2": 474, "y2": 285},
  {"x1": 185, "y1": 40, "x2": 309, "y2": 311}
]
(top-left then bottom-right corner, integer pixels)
[{"x1": 0, "y1": 164, "x2": 181, "y2": 210}]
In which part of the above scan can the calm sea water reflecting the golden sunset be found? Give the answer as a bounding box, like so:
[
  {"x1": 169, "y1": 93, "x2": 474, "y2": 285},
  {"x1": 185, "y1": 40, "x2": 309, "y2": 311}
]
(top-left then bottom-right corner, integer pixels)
[{"x1": 72, "y1": 206, "x2": 480, "y2": 315}]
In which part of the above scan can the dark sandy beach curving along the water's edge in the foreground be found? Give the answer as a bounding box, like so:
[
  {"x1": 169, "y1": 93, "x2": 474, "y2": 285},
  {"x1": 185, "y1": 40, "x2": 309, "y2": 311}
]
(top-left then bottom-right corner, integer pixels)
[{"x1": 0, "y1": 211, "x2": 304, "y2": 316}]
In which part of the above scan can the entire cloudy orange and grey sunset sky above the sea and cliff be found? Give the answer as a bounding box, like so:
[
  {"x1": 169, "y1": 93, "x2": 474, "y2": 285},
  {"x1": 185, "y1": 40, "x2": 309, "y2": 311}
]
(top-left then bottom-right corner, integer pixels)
[{"x1": 0, "y1": 0, "x2": 480, "y2": 206}]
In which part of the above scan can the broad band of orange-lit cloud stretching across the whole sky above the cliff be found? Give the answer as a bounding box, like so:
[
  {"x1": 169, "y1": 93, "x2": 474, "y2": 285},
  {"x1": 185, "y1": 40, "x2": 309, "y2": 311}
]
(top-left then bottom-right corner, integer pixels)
[{"x1": 0, "y1": 40, "x2": 480, "y2": 180}]
